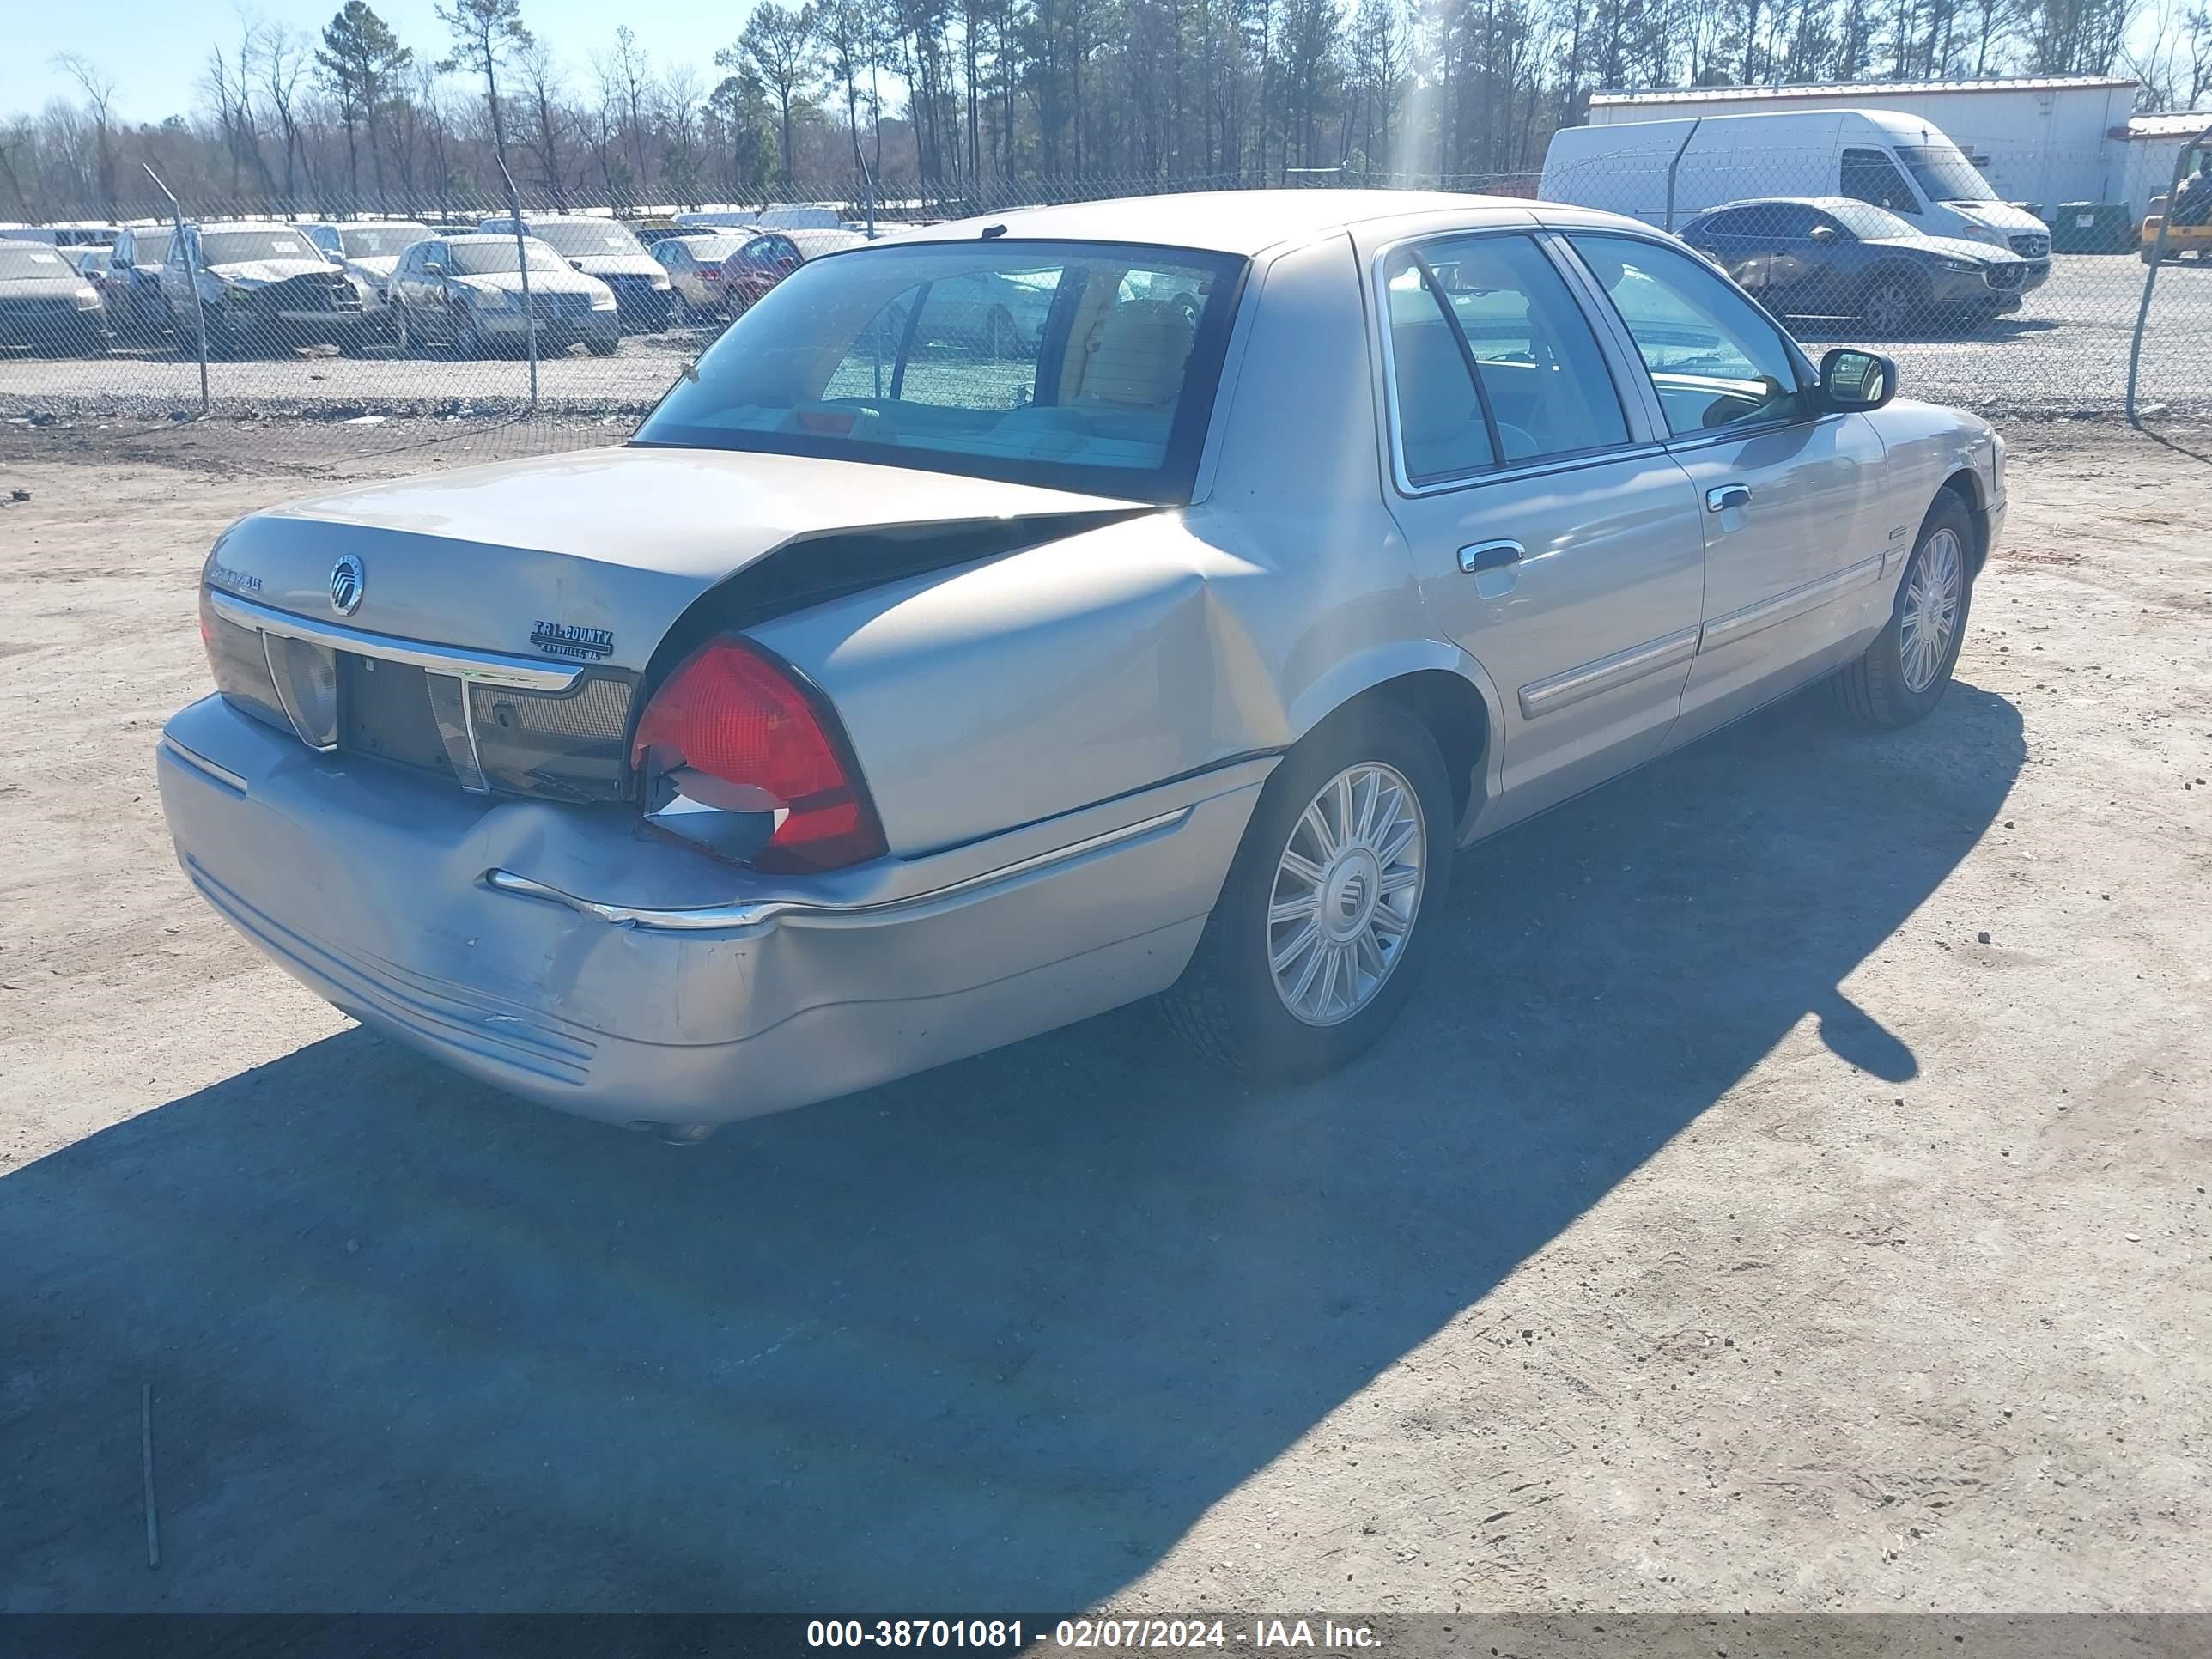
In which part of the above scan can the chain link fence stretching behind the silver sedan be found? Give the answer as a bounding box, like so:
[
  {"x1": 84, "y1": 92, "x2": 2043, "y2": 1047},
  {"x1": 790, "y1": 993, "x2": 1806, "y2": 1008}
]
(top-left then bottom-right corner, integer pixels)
[{"x1": 0, "y1": 151, "x2": 2212, "y2": 453}]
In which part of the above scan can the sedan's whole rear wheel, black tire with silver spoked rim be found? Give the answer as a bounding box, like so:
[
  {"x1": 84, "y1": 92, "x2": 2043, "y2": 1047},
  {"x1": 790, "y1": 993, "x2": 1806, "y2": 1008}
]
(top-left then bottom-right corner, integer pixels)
[{"x1": 1161, "y1": 696, "x2": 1453, "y2": 1084}]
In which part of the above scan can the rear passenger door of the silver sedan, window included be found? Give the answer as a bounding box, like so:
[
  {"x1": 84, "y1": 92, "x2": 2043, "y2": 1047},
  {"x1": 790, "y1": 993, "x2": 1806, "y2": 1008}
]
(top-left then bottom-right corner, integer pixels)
[{"x1": 1380, "y1": 232, "x2": 1704, "y2": 830}]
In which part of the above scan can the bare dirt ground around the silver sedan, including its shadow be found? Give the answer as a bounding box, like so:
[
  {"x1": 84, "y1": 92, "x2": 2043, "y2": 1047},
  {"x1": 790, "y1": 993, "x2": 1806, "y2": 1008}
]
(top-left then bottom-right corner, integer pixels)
[{"x1": 0, "y1": 425, "x2": 2212, "y2": 1613}]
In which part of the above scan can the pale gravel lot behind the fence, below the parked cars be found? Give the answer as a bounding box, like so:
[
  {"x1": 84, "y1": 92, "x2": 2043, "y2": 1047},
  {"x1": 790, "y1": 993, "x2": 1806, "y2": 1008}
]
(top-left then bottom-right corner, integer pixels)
[{"x1": 13, "y1": 254, "x2": 2212, "y2": 422}]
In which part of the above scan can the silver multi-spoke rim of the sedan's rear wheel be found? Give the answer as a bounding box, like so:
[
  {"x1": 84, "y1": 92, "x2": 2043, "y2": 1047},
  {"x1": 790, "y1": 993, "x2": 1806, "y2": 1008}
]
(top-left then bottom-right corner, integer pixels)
[{"x1": 1267, "y1": 761, "x2": 1427, "y2": 1026}]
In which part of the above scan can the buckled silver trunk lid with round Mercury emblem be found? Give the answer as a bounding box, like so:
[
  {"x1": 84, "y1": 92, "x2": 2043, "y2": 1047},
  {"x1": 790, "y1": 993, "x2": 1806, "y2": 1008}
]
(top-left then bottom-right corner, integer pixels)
[{"x1": 204, "y1": 447, "x2": 1130, "y2": 671}]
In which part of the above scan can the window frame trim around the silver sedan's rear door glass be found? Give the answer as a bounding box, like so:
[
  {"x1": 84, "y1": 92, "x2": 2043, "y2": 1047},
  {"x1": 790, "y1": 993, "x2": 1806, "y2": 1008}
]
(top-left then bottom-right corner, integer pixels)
[{"x1": 1367, "y1": 223, "x2": 1666, "y2": 500}]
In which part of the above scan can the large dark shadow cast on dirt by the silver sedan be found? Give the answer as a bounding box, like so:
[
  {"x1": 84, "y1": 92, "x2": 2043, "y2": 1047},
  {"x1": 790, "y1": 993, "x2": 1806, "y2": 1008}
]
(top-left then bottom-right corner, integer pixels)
[{"x1": 0, "y1": 686, "x2": 2024, "y2": 1610}]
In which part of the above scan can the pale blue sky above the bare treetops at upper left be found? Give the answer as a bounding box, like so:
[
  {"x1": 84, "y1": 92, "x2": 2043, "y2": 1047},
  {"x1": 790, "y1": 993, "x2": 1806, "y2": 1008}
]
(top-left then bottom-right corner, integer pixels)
[{"x1": 0, "y1": 0, "x2": 752, "y2": 122}]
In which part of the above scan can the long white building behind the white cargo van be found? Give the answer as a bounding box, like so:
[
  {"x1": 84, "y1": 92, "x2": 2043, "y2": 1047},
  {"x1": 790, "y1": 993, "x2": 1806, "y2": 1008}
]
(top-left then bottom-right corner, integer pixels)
[{"x1": 1590, "y1": 76, "x2": 2141, "y2": 212}]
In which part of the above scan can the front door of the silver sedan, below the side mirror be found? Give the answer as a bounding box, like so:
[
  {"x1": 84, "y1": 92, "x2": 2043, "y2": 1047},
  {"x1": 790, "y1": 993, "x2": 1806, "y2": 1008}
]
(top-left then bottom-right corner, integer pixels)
[{"x1": 1568, "y1": 232, "x2": 1898, "y2": 744}]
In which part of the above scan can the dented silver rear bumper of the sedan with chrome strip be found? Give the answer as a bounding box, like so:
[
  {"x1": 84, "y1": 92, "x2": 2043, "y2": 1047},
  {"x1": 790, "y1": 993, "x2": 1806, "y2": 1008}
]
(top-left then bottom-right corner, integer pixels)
[{"x1": 157, "y1": 696, "x2": 1272, "y2": 1124}]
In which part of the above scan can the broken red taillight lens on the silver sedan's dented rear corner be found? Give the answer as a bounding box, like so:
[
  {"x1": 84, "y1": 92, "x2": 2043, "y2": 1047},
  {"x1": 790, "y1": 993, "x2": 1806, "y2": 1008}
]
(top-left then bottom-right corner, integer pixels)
[{"x1": 630, "y1": 637, "x2": 884, "y2": 872}]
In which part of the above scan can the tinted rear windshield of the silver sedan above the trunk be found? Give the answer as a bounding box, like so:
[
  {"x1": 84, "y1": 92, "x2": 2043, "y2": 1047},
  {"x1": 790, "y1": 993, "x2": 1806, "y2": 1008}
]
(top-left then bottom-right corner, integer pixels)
[{"x1": 635, "y1": 241, "x2": 1243, "y2": 502}]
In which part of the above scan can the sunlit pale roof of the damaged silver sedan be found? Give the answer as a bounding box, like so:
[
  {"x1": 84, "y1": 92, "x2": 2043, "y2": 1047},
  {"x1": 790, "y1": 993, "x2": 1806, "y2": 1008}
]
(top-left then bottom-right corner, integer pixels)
[{"x1": 896, "y1": 191, "x2": 1613, "y2": 254}]
